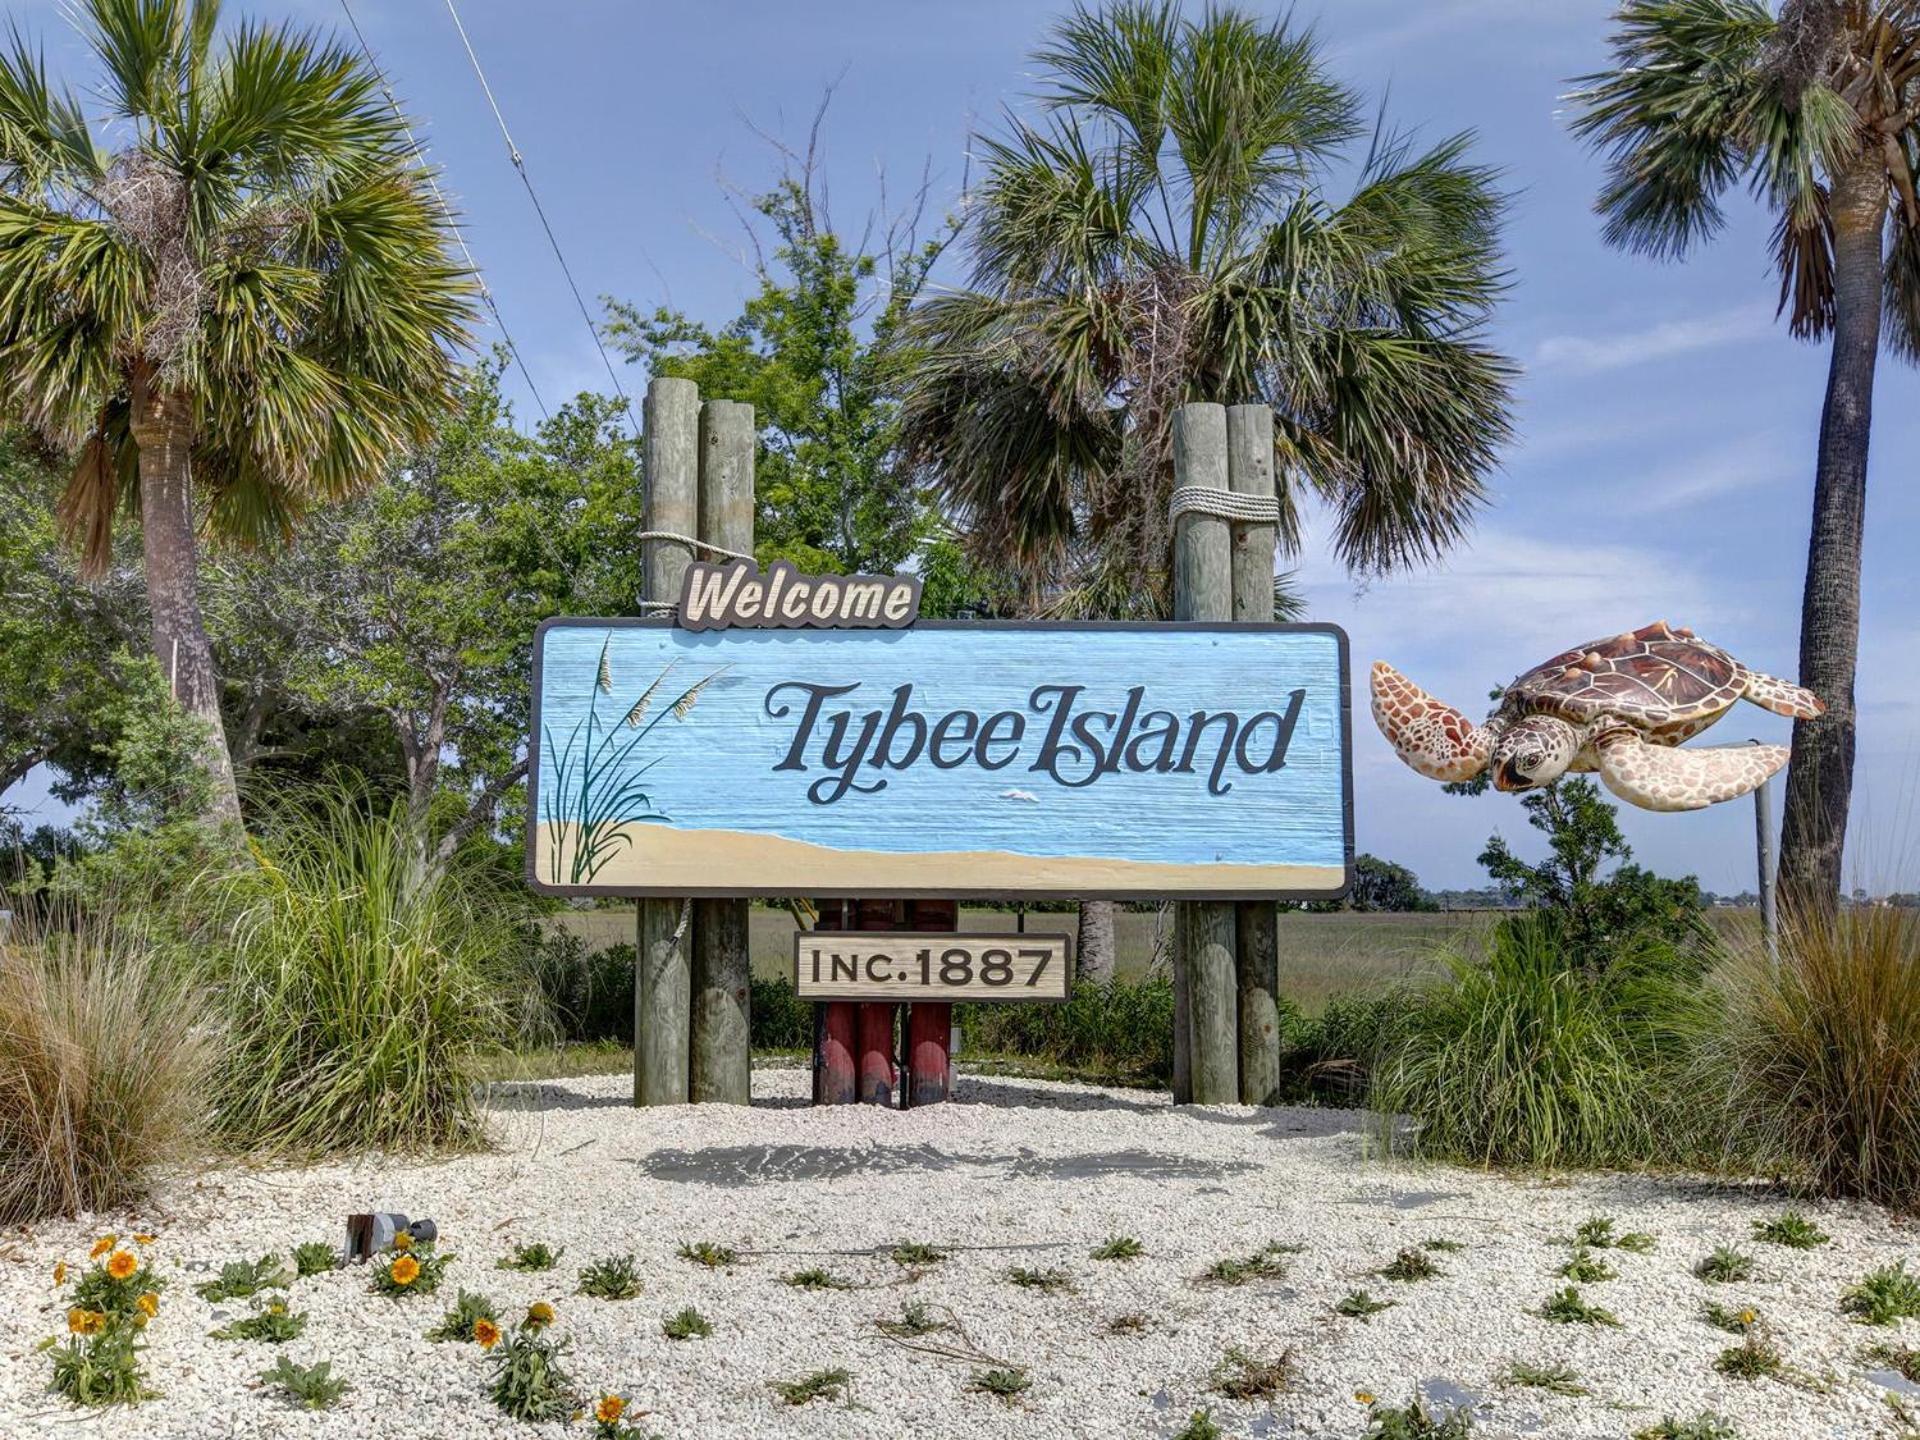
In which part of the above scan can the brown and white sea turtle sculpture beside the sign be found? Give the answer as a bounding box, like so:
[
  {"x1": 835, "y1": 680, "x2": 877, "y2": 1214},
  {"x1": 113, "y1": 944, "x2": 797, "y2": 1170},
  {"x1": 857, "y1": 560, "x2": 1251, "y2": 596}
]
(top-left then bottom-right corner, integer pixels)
[{"x1": 1373, "y1": 620, "x2": 1826, "y2": 810}]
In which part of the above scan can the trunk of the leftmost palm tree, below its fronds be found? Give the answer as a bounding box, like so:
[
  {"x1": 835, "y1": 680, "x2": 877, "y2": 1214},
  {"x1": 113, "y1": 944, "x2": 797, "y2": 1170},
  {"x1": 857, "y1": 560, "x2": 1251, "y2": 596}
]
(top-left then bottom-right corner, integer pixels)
[{"x1": 132, "y1": 374, "x2": 240, "y2": 824}]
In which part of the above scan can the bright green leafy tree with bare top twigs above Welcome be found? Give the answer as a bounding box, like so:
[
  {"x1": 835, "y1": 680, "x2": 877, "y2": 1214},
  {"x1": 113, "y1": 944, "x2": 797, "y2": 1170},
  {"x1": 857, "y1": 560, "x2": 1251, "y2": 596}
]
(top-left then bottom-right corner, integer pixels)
[{"x1": 607, "y1": 123, "x2": 947, "y2": 574}]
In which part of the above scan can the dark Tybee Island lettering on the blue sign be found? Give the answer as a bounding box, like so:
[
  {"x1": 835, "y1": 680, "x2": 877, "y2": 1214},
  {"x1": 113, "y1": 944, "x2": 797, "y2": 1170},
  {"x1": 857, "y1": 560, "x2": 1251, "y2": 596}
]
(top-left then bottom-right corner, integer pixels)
[{"x1": 766, "y1": 680, "x2": 1308, "y2": 804}]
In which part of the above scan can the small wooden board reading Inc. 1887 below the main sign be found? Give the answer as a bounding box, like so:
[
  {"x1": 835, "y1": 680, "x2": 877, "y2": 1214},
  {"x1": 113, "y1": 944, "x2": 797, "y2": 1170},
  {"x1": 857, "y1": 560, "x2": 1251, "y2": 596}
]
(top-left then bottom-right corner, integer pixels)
[{"x1": 793, "y1": 929, "x2": 1073, "y2": 1004}]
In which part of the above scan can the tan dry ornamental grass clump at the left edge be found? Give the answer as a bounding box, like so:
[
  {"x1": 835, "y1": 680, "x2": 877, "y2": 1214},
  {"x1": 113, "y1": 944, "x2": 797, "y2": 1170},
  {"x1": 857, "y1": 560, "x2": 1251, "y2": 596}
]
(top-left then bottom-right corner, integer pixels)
[{"x1": 0, "y1": 906, "x2": 211, "y2": 1225}]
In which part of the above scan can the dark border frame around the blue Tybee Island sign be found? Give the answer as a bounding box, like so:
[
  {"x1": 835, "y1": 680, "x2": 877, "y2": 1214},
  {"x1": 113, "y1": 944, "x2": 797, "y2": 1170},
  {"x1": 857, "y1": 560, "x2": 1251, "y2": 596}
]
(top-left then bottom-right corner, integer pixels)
[{"x1": 526, "y1": 614, "x2": 1354, "y2": 902}]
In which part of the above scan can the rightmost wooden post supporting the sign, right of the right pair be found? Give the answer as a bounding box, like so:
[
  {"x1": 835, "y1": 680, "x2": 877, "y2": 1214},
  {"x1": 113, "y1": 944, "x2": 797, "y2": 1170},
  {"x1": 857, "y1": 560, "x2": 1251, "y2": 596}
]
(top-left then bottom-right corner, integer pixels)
[{"x1": 1227, "y1": 405, "x2": 1281, "y2": 1106}]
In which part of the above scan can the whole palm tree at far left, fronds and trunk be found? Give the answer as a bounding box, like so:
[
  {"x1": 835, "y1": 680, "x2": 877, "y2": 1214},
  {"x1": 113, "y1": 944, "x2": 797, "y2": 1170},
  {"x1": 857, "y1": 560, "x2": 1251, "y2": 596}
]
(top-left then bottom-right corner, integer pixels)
[{"x1": 0, "y1": 0, "x2": 472, "y2": 820}]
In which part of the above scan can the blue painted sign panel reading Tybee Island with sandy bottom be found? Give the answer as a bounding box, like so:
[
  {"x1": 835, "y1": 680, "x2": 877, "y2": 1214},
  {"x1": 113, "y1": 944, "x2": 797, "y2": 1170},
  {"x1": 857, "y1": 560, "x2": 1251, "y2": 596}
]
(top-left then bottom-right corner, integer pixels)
[{"x1": 528, "y1": 620, "x2": 1354, "y2": 899}]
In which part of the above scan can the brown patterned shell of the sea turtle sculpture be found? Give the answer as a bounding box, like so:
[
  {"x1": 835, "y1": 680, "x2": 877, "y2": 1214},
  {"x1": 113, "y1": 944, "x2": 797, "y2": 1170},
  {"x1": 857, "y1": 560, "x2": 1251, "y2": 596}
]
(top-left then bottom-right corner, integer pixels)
[{"x1": 1505, "y1": 620, "x2": 1745, "y2": 730}]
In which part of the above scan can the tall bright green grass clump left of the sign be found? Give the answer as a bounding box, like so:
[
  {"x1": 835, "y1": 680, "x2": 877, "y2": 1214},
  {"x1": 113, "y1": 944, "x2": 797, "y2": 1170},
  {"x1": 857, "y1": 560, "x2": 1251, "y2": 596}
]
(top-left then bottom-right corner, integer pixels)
[{"x1": 215, "y1": 789, "x2": 515, "y2": 1152}]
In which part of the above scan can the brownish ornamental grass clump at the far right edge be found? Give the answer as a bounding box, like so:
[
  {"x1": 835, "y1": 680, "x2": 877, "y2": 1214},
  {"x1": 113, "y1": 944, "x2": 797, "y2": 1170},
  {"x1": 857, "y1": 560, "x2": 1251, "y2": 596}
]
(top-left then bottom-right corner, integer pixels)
[{"x1": 1724, "y1": 908, "x2": 1920, "y2": 1212}]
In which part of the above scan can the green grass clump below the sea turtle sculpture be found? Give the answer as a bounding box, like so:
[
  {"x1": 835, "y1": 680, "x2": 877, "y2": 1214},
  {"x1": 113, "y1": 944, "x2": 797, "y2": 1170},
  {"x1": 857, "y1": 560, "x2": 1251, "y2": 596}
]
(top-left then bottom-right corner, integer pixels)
[{"x1": 1373, "y1": 922, "x2": 1711, "y2": 1165}]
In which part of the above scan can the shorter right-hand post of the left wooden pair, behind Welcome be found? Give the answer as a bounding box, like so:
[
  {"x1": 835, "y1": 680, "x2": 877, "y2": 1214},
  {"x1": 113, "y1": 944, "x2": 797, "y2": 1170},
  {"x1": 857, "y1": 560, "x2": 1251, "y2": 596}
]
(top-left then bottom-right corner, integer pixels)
[{"x1": 689, "y1": 399, "x2": 755, "y2": 1106}]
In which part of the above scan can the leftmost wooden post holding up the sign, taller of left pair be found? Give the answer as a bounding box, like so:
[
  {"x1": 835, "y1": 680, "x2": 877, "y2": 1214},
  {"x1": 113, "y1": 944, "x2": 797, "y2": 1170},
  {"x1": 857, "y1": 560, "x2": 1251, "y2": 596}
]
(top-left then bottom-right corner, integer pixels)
[{"x1": 634, "y1": 376, "x2": 701, "y2": 1106}]
